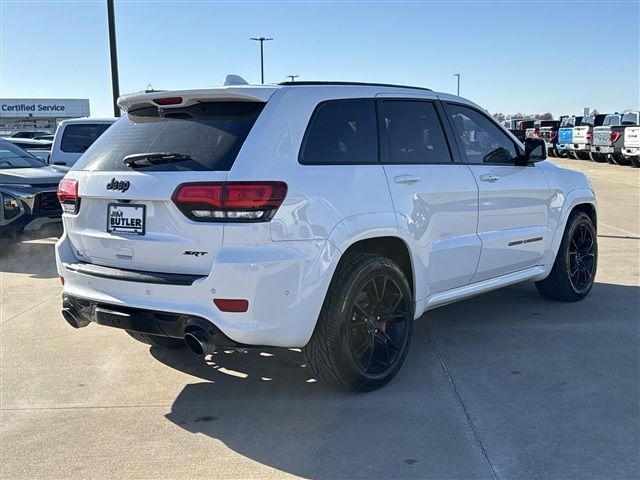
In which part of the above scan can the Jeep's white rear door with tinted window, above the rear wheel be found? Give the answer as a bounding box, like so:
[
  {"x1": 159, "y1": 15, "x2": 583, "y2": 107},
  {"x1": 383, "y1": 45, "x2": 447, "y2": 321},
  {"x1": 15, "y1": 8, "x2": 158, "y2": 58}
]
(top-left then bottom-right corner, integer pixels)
[{"x1": 378, "y1": 98, "x2": 480, "y2": 298}]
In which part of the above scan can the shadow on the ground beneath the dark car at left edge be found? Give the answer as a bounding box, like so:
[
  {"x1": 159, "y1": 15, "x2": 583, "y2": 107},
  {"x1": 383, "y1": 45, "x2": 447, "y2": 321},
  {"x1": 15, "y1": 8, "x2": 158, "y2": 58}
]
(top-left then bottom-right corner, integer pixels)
[{"x1": 0, "y1": 225, "x2": 62, "y2": 278}]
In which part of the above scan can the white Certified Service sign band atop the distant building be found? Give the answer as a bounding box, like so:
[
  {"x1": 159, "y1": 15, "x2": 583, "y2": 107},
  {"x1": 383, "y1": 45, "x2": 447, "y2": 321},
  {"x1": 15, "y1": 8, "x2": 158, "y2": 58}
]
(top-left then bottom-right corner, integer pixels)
[{"x1": 0, "y1": 98, "x2": 90, "y2": 118}]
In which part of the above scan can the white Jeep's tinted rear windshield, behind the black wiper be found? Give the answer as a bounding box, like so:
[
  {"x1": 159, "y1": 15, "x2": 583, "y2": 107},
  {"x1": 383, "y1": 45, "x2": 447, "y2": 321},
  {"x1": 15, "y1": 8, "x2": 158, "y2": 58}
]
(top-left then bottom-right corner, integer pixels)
[{"x1": 73, "y1": 102, "x2": 265, "y2": 171}]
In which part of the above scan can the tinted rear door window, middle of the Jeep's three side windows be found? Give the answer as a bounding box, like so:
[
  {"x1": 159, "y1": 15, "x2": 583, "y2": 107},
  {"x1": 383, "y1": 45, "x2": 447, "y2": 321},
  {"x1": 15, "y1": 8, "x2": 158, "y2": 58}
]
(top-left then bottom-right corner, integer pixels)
[{"x1": 382, "y1": 100, "x2": 452, "y2": 164}]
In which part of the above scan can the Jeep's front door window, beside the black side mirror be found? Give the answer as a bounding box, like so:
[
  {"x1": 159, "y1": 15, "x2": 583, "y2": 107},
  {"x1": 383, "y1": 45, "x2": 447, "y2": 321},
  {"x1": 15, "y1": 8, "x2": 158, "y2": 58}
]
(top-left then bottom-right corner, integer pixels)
[{"x1": 448, "y1": 104, "x2": 518, "y2": 164}]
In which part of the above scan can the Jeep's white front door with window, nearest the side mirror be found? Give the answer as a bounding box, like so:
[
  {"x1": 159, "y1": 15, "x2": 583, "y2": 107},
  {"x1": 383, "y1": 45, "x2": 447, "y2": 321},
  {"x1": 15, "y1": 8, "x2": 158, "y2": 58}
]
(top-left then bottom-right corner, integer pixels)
[{"x1": 445, "y1": 103, "x2": 551, "y2": 282}]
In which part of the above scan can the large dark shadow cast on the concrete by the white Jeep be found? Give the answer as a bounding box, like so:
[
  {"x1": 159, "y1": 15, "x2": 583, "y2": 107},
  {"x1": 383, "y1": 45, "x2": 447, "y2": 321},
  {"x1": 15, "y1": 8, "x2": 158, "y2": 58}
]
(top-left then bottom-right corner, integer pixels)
[{"x1": 151, "y1": 283, "x2": 640, "y2": 478}]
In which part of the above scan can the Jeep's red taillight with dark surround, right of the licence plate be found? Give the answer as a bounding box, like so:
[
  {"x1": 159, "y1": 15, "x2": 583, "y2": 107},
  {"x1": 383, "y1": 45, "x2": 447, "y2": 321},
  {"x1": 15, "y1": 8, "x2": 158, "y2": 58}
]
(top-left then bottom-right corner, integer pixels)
[{"x1": 172, "y1": 182, "x2": 287, "y2": 222}]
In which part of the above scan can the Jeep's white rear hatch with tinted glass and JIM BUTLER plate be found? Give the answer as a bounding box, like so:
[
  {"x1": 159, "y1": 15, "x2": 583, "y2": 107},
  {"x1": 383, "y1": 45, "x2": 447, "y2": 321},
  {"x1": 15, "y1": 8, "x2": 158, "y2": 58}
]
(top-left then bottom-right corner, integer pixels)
[{"x1": 63, "y1": 94, "x2": 265, "y2": 274}]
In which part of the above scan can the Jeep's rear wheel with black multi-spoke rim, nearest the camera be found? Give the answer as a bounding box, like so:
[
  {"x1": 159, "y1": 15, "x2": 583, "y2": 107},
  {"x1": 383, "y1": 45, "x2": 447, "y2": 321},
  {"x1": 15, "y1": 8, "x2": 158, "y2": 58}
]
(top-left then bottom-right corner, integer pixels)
[{"x1": 303, "y1": 253, "x2": 414, "y2": 392}]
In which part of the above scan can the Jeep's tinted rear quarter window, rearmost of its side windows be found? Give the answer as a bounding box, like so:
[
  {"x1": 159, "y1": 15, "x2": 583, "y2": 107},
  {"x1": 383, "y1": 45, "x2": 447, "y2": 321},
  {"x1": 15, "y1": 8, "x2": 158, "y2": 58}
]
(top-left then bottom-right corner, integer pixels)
[{"x1": 300, "y1": 99, "x2": 378, "y2": 165}]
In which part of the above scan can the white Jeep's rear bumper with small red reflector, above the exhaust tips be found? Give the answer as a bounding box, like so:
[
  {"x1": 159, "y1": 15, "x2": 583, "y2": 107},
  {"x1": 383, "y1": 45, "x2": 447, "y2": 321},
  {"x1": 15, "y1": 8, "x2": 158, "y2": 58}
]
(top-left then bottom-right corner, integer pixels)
[{"x1": 56, "y1": 233, "x2": 339, "y2": 348}]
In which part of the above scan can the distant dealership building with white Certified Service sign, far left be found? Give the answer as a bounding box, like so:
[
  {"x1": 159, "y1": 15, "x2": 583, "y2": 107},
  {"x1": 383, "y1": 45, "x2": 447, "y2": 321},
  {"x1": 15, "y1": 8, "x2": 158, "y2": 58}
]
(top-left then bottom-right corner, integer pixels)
[{"x1": 0, "y1": 98, "x2": 90, "y2": 135}]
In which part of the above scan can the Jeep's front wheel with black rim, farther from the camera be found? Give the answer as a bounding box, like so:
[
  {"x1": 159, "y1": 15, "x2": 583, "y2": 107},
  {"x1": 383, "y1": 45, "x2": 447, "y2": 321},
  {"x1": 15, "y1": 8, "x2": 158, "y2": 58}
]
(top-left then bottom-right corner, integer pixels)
[{"x1": 536, "y1": 212, "x2": 598, "y2": 302}]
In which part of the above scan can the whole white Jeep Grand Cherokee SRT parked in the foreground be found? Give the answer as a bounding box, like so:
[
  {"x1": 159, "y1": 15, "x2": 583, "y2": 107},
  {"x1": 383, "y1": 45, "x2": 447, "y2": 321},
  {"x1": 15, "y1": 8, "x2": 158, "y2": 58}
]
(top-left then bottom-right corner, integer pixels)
[{"x1": 56, "y1": 82, "x2": 597, "y2": 391}]
